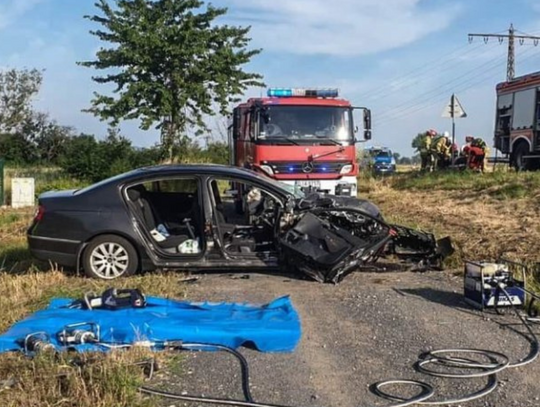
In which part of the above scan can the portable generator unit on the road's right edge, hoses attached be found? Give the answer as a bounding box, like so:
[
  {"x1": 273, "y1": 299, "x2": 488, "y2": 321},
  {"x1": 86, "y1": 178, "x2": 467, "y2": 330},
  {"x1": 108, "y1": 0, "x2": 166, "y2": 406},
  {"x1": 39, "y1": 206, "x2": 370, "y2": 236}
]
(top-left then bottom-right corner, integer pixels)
[{"x1": 463, "y1": 260, "x2": 527, "y2": 310}]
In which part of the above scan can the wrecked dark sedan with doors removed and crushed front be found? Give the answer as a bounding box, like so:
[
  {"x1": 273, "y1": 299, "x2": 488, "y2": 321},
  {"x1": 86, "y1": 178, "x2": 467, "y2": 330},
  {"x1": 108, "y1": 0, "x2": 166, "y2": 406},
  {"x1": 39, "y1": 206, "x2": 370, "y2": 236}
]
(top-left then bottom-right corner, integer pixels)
[{"x1": 28, "y1": 165, "x2": 452, "y2": 283}]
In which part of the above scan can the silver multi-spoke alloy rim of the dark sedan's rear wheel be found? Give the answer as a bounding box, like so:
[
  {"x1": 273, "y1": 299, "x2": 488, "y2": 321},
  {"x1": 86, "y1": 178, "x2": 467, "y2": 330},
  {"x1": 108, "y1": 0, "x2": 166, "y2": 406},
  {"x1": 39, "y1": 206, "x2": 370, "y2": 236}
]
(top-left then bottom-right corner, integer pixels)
[{"x1": 90, "y1": 242, "x2": 129, "y2": 279}]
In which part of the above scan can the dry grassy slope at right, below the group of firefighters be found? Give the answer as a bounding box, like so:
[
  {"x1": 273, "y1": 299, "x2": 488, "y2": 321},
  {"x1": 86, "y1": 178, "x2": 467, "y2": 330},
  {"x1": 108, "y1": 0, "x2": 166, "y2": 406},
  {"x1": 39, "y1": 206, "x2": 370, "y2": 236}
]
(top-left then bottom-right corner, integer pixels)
[{"x1": 360, "y1": 173, "x2": 540, "y2": 289}]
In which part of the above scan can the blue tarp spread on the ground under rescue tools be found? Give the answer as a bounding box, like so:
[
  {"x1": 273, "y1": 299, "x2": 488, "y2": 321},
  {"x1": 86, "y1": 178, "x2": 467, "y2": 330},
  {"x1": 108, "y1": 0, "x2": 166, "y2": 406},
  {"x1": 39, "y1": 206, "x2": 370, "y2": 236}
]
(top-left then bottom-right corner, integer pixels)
[{"x1": 0, "y1": 297, "x2": 301, "y2": 352}]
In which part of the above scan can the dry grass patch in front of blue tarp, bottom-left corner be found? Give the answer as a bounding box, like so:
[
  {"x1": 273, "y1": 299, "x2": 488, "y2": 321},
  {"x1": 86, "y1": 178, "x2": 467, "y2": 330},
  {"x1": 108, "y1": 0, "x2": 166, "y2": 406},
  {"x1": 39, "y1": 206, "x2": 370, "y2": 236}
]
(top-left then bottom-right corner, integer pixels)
[{"x1": 0, "y1": 349, "x2": 156, "y2": 407}]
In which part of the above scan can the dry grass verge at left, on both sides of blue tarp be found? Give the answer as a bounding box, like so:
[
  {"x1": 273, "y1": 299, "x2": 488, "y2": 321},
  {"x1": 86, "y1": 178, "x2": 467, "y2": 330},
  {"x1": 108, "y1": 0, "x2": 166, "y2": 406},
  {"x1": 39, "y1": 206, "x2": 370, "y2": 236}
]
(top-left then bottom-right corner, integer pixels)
[{"x1": 0, "y1": 209, "x2": 192, "y2": 407}]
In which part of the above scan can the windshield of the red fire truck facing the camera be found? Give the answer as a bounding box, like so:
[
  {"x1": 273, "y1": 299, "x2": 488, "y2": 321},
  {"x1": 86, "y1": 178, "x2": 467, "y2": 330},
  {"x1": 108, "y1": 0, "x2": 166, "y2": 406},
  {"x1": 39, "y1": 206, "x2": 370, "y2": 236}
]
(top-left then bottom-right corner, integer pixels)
[{"x1": 259, "y1": 105, "x2": 354, "y2": 142}]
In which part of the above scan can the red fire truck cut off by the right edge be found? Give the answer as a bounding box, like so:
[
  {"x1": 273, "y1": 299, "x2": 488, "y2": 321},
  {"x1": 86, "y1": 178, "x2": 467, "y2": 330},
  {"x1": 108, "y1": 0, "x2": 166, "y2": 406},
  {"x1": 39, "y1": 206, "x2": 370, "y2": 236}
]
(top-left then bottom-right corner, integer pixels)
[{"x1": 494, "y1": 72, "x2": 540, "y2": 170}]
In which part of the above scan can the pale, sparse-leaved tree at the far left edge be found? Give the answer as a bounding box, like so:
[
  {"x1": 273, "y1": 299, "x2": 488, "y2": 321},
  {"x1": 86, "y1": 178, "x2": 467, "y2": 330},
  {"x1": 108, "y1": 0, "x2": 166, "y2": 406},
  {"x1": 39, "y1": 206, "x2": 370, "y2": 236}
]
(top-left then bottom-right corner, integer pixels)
[{"x1": 0, "y1": 69, "x2": 43, "y2": 133}]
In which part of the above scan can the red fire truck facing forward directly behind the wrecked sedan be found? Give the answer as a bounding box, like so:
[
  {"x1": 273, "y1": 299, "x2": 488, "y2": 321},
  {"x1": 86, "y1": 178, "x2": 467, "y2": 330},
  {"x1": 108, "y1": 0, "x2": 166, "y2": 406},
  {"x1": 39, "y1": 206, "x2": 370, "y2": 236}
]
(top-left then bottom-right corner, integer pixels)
[{"x1": 229, "y1": 88, "x2": 371, "y2": 196}]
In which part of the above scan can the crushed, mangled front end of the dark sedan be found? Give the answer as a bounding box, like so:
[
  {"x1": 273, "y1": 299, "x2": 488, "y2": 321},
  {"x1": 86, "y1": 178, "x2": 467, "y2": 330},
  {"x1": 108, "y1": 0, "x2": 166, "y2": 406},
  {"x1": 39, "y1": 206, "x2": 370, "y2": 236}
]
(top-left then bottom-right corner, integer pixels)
[{"x1": 278, "y1": 194, "x2": 453, "y2": 283}]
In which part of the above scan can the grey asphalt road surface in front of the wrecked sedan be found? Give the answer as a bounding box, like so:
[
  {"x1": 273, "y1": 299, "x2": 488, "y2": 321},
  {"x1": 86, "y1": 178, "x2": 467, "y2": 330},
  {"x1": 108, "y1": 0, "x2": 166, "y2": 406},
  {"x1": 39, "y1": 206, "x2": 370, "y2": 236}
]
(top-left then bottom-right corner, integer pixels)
[{"x1": 150, "y1": 272, "x2": 540, "y2": 407}]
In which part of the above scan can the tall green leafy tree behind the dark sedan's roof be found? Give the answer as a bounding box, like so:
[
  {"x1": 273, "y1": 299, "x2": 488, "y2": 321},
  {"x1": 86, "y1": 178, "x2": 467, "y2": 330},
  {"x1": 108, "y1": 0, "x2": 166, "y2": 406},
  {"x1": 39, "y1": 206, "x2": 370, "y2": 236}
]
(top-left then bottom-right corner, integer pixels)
[{"x1": 80, "y1": 0, "x2": 263, "y2": 159}]
